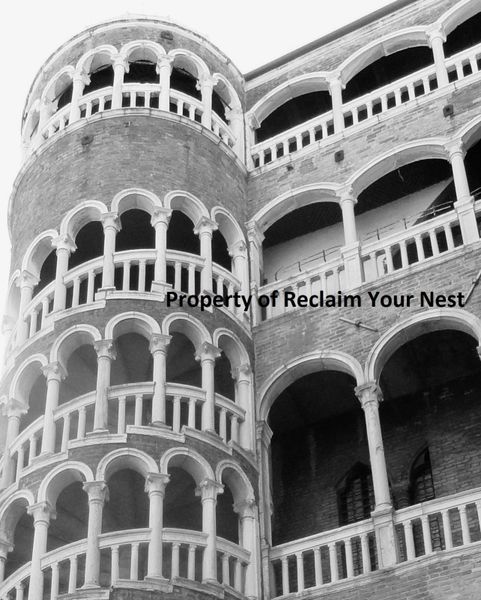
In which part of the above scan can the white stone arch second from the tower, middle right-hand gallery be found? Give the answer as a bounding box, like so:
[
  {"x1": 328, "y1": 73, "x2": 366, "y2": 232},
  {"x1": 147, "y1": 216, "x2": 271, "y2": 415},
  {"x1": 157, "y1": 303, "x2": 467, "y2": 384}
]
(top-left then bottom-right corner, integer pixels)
[{"x1": 346, "y1": 138, "x2": 449, "y2": 196}]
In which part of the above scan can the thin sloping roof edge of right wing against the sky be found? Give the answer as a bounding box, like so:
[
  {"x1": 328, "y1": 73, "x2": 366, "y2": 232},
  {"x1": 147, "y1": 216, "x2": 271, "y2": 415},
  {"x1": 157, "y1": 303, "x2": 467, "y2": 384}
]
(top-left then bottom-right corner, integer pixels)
[{"x1": 244, "y1": 0, "x2": 418, "y2": 82}]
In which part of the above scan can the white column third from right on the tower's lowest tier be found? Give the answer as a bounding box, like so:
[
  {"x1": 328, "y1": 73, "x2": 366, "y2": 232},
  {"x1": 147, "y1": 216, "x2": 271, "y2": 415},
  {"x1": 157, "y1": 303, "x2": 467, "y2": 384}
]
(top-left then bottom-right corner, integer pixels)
[{"x1": 145, "y1": 473, "x2": 170, "y2": 579}]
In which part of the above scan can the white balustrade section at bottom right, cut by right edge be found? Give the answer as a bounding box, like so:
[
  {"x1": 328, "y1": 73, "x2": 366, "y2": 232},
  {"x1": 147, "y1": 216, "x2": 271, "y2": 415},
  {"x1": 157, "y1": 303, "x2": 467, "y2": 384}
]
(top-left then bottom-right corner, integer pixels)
[{"x1": 394, "y1": 488, "x2": 481, "y2": 562}]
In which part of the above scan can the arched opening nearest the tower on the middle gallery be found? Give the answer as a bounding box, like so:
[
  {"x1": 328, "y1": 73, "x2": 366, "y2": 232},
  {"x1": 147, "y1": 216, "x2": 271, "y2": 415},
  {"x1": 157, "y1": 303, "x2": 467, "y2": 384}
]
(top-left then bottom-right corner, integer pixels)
[{"x1": 262, "y1": 200, "x2": 344, "y2": 284}]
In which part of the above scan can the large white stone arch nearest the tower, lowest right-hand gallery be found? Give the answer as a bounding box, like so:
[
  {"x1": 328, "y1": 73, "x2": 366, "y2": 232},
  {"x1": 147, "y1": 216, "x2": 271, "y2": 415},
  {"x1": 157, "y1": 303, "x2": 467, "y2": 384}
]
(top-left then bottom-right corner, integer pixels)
[{"x1": 259, "y1": 350, "x2": 365, "y2": 421}]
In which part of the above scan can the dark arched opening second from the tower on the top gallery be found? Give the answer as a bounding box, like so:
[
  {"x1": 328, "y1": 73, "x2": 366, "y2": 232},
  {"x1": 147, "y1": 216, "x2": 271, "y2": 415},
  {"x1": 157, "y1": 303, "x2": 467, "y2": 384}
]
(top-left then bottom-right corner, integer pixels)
[{"x1": 342, "y1": 46, "x2": 437, "y2": 106}]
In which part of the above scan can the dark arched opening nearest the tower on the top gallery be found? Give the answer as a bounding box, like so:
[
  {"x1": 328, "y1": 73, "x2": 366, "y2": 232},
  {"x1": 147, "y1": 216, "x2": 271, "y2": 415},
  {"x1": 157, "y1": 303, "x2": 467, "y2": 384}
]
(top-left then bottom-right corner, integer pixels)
[{"x1": 255, "y1": 90, "x2": 332, "y2": 143}]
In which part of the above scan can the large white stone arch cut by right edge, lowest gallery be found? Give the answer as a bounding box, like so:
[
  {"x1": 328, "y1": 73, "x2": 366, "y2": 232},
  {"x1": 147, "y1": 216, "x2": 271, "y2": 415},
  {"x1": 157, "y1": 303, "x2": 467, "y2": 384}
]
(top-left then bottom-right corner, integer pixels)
[{"x1": 365, "y1": 308, "x2": 481, "y2": 381}]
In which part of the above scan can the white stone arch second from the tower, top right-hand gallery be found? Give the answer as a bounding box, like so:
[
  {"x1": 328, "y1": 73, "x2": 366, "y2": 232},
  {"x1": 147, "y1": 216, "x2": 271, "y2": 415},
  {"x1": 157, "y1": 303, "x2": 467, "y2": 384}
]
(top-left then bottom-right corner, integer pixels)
[{"x1": 338, "y1": 27, "x2": 434, "y2": 85}]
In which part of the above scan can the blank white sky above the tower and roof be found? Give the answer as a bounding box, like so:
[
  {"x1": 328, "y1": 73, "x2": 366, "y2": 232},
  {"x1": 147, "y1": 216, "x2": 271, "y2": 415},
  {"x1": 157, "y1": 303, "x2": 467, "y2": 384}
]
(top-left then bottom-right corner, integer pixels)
[{"x1": 0, "y1": 0, "x2": 390, "y2": 326}]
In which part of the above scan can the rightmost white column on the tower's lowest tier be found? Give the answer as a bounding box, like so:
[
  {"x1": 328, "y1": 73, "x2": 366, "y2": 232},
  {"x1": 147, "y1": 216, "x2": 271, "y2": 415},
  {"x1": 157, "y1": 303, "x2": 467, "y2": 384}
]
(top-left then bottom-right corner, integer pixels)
[{"x1": 234, "y1": 498, "x2": 261, "y2": 599}]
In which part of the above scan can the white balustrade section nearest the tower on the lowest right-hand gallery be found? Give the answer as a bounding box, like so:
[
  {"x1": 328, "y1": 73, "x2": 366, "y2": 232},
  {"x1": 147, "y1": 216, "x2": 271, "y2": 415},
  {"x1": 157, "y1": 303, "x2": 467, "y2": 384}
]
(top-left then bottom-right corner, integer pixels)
[{"x1": 270, "y1": 519, "x2": 377, "y2": 597}]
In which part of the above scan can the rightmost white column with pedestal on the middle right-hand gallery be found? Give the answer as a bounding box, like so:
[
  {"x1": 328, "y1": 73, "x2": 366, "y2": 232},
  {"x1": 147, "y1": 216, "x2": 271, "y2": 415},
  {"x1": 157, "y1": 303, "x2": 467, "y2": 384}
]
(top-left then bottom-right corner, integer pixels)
[{"x1": 446, "y1": 140, "x2": 479, "y2": 244}]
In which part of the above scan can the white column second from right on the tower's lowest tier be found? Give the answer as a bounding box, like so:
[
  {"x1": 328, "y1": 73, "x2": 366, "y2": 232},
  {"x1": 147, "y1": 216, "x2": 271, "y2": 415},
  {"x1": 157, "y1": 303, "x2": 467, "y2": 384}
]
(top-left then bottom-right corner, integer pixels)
[{"x1": 195, "y1": 479, "x2": 224, "y2": 585}]
